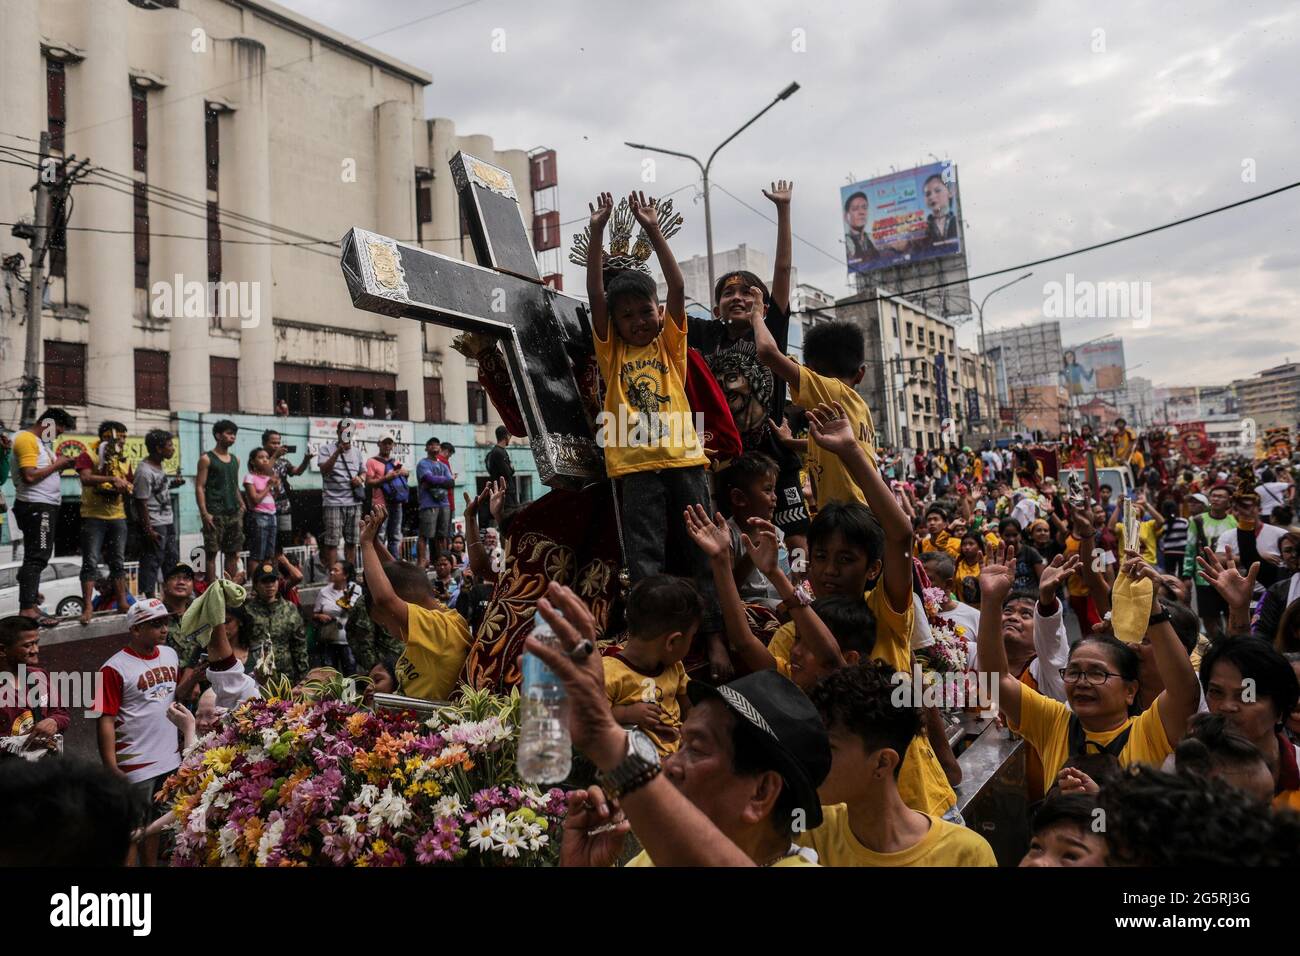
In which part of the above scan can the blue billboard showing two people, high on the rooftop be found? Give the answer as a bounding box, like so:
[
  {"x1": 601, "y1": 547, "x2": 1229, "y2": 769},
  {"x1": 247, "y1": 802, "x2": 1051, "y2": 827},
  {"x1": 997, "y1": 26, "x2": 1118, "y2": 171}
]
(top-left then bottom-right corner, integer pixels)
[{"x1": 840, "y1": 163, "x2": 962, "y2": 273}]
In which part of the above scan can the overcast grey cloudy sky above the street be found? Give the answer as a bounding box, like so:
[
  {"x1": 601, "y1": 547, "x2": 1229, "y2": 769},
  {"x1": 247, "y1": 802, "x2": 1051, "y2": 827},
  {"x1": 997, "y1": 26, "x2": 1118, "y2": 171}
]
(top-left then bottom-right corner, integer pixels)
[{"x1": 287, "y1": 0, "x2": 1300, "y2": 385}]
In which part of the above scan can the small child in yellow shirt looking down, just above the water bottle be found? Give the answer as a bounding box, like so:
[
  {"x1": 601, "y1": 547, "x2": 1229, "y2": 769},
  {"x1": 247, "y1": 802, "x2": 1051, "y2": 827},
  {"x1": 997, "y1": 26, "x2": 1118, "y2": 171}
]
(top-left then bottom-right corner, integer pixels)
[{"x1": 602, "y1": 575, "x2": 705, "y2": 757}]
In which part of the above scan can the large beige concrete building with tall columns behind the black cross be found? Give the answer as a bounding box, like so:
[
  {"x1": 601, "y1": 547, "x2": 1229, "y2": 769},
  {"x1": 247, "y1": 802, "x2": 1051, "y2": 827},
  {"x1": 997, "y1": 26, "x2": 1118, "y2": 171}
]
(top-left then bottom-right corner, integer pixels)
[{"x1": 0, "y1": 0, "x2": 548, "y2": 441}]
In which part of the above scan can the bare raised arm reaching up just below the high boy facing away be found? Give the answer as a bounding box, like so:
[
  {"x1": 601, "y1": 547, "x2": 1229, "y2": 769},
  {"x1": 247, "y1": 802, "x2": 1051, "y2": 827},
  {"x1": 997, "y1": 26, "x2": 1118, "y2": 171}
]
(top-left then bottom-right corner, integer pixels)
[{"x1": 809, "y1": 402, "x2": 909, "y2": 614}]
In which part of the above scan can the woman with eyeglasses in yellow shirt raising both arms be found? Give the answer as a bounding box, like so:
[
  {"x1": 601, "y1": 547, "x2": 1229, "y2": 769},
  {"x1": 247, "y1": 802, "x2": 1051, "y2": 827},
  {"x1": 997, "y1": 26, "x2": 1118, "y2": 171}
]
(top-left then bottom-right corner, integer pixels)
[{"x1": 978, "y1": 551, "x2": 1200, "y2": 780}]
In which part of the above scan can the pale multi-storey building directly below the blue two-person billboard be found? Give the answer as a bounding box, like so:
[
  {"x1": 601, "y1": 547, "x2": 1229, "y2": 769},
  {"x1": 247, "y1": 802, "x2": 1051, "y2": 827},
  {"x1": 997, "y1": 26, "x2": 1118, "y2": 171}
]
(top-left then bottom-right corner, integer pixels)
[{"x1": 836, "y1": 287, "x2": 992, "y2": 449}]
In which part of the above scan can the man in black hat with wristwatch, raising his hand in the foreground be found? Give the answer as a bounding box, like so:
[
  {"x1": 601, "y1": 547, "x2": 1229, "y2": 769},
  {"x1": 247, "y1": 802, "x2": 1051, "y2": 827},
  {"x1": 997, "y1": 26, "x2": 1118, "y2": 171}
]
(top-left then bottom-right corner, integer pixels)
[{"x1": 528, "y1": 583, "x2": 831, "y2": 866}]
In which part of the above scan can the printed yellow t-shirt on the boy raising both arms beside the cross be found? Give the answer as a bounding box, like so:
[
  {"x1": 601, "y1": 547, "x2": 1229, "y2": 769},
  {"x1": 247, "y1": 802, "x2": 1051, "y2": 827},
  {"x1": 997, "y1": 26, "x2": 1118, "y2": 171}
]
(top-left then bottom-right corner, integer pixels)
[{"x1": 592, "y1": 315, "x2": 709, "y2": 477}]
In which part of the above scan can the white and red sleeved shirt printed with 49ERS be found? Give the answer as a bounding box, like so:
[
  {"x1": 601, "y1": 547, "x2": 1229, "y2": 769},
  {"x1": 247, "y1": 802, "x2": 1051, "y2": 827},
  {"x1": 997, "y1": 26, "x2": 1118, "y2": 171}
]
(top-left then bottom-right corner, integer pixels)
[{"x1": 99, "y1": 645, "x2": 181, "y2": 783}]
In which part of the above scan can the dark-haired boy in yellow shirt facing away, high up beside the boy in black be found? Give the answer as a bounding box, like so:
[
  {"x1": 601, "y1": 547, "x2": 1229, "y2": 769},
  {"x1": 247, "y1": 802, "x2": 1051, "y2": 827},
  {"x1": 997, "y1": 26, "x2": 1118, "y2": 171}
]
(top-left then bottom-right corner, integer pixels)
[{"x1": 750, "y1": 311, "x2": 873, "y2": 509}]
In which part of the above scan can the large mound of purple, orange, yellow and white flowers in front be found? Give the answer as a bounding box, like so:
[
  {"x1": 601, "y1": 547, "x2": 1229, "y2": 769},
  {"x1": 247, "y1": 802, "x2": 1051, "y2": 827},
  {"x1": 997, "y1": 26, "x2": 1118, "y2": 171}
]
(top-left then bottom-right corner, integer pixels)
[{"x1": 163, "y1": 679, "x2": 564, "y2": 866}]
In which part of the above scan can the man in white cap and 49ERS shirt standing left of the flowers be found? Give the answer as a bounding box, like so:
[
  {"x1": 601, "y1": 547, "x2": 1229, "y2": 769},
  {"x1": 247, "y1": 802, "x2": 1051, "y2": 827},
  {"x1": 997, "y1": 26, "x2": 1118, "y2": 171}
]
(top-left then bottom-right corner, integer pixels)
[{"x1": 95, "y1": 597, "x2": 181, "y2": 865}]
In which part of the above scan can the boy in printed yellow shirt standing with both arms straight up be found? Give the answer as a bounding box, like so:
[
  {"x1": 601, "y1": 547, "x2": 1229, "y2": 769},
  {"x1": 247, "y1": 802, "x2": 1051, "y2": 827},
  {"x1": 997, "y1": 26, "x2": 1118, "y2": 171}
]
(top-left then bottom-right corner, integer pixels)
[{"x1": 586, "y1": 193, "x2": 725, "y2": 660}]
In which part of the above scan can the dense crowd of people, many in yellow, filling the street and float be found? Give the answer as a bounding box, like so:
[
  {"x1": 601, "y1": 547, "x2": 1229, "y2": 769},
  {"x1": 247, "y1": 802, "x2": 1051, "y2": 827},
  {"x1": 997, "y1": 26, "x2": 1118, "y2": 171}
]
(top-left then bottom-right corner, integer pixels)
[{"x1": 0, "y1": 175, "x2": 1300, "y2": 866}]
